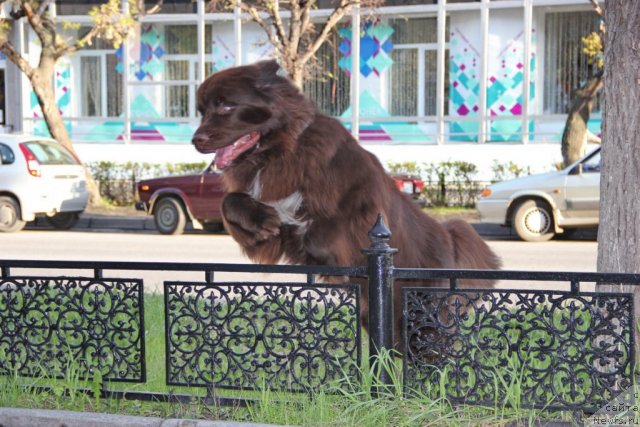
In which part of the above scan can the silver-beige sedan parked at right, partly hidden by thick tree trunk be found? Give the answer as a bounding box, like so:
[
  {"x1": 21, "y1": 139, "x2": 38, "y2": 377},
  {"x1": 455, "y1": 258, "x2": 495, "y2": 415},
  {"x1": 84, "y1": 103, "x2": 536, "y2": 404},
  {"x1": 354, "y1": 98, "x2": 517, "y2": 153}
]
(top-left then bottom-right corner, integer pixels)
[{"x1": 476, "y1": 148, "x2": 600, "y2": 242}]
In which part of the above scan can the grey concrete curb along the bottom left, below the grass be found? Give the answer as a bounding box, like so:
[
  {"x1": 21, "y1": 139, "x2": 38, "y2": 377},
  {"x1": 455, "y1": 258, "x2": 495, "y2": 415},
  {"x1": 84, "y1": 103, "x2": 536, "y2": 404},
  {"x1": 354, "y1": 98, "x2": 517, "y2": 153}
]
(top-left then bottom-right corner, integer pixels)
[{"x1": 0, "y1": 408, "x2": 282, "y2": 427}]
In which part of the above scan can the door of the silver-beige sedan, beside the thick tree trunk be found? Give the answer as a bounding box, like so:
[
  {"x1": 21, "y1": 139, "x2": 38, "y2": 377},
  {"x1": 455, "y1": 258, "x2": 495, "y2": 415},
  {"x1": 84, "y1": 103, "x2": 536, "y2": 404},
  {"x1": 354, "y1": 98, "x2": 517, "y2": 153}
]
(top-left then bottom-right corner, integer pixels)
[{"x1": 564, "y1": 149, "x2": 600, "y2": 223}]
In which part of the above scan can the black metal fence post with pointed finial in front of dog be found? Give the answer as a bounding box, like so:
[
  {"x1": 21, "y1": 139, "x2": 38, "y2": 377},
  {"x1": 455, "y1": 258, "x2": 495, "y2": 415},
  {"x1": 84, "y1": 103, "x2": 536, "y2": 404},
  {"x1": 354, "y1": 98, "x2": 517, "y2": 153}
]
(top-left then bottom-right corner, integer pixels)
[{"x1": 362, "y1": 214, "x2": 398, "y2": 396}]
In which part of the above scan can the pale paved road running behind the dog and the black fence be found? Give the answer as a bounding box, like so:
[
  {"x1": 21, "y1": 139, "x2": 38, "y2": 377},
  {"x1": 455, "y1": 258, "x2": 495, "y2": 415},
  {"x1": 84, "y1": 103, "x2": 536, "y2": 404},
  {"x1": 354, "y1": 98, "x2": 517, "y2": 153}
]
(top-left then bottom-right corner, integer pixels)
[{"x1": 0, "y1": 229, "x2": 597, "y2": 290}]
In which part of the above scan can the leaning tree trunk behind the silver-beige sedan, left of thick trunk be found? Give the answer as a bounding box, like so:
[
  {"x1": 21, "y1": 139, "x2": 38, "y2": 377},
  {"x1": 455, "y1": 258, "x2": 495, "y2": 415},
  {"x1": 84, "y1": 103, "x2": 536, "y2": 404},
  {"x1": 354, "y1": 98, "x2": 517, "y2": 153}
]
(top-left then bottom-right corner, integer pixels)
[{"x1": 561, "y1": 73, "x2": 602, "y2": 167}]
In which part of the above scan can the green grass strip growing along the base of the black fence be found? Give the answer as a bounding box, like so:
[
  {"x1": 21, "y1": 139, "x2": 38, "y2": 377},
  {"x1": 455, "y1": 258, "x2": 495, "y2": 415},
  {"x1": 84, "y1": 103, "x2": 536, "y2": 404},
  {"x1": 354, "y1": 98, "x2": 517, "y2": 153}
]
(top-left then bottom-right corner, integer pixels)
[{"x1": 0, "y1": 294, "x2": 596, "y2": 427}]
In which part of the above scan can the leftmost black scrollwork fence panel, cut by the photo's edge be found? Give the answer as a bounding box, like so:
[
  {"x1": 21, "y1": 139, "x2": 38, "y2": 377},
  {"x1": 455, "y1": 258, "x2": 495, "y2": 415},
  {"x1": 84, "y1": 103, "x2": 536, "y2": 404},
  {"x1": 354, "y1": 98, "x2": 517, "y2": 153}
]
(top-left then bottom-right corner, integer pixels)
[{"x1": 0, "y1": 277, "x2": 145, "y2": 382}]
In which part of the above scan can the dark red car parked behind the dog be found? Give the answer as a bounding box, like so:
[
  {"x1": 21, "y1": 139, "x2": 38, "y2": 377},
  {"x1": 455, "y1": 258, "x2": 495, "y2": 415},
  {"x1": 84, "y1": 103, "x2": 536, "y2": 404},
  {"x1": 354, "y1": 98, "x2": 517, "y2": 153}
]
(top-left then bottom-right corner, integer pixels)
[{"x1": 136, "y1": 163, "x2": 423, "y2": 234}]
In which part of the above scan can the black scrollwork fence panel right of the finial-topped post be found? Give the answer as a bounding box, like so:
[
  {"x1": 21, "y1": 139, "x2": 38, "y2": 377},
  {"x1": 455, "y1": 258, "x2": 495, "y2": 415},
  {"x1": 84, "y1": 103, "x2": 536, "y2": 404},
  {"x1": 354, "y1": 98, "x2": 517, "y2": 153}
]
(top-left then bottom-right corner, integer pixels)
[{"x1": 404, "y1": 288, "x2": 634, "y2": 409}]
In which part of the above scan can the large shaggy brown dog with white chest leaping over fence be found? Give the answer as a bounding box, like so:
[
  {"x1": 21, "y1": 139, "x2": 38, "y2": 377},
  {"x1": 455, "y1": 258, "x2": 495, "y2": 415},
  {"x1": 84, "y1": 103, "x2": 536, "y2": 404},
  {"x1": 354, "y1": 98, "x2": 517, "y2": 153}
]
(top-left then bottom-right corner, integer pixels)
[{"x1": 193, "y1": 61, "x2": 500, "y2": 348}]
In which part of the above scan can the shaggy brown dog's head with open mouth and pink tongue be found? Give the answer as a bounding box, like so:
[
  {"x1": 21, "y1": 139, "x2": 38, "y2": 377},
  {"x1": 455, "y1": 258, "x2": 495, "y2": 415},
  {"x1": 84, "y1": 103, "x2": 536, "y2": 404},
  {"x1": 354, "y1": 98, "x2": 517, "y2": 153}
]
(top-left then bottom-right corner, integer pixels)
[{"x1": 192, "y1": 61, "x2": 313, "y2": 169}]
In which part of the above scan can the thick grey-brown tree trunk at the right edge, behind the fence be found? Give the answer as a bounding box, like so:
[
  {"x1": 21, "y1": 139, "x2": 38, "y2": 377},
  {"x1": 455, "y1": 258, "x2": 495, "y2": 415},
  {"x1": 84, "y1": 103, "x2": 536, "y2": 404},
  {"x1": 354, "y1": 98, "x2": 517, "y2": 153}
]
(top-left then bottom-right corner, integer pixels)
[{"x1": 597, "y1": 0, "x2": 640, "y2": 348}]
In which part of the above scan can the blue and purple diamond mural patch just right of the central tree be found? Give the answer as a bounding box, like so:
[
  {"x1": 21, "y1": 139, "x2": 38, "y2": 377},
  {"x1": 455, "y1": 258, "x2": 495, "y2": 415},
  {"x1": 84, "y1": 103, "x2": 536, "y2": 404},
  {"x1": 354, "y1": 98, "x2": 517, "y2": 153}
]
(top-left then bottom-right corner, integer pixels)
[{"x1": 338, "y1": 21, "x2": 393, "y2": 77}]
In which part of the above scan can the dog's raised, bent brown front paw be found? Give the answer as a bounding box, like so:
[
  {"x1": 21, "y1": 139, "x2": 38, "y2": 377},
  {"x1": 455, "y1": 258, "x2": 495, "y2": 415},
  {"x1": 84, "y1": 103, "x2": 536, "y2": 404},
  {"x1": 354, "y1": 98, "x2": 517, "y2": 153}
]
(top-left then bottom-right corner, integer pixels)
[{"x1": 222, "y1": 193, "x2": 281, "y2": 248}]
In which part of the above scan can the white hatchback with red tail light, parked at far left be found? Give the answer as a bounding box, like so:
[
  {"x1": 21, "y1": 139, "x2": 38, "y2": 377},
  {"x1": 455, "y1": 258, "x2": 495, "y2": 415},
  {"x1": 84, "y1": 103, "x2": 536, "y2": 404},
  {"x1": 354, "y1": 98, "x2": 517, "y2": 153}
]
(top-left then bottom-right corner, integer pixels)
[{"x1": 0, "y1": 134, "x2": 89, "y2": 232}]
